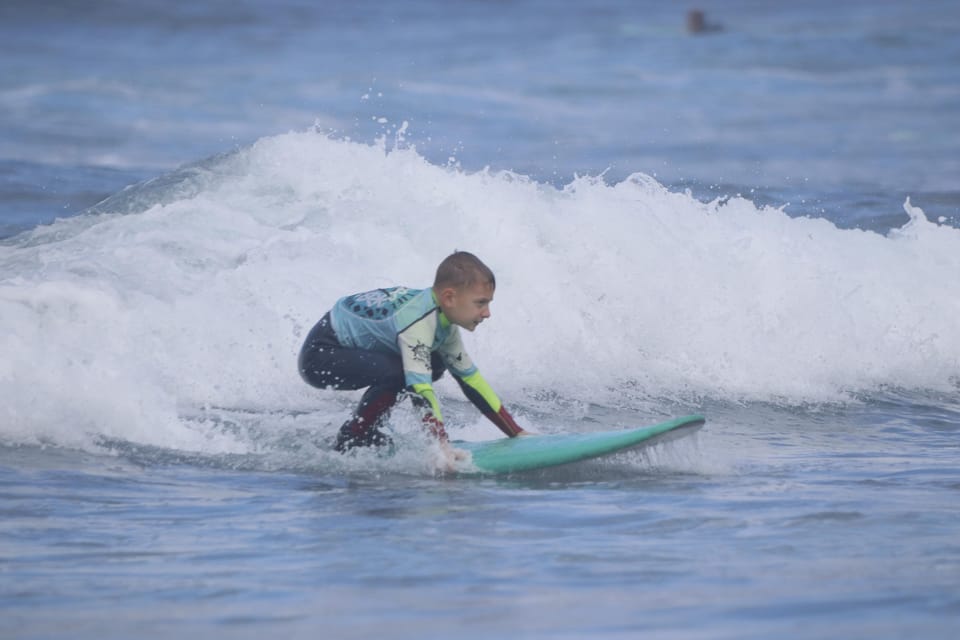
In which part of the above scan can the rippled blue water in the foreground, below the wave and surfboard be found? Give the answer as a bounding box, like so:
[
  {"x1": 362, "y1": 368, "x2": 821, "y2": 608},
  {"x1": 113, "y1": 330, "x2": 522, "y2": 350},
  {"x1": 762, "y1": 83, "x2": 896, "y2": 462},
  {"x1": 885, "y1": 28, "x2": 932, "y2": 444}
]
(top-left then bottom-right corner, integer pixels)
[{"x1": 0, "y1": 403, "x2": 960, "y2": 638}]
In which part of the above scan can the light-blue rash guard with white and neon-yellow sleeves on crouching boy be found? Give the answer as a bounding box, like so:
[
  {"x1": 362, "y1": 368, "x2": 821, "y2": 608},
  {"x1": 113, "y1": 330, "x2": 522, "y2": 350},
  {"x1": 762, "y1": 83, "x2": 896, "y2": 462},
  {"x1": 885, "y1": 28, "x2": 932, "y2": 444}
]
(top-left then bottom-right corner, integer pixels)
[{"x1": 330, "y1": 287, "x2": 506, "y2": 422}]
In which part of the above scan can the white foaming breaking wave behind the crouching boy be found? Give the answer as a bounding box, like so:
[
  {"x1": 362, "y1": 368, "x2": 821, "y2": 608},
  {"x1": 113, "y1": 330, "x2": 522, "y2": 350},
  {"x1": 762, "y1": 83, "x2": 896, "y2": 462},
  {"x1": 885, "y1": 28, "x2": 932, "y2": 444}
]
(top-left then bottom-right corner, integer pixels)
[{"x1": 0, "y1": 133, "x2": 960, "y2": 452}]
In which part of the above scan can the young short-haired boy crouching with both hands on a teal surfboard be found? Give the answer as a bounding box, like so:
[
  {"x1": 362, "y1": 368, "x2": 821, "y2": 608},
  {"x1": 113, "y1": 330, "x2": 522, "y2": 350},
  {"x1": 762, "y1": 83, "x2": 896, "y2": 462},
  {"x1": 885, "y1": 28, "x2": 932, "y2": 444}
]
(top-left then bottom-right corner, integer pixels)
[{"x1": 299, "y1": 251, "x2": 526, "y2": 466}]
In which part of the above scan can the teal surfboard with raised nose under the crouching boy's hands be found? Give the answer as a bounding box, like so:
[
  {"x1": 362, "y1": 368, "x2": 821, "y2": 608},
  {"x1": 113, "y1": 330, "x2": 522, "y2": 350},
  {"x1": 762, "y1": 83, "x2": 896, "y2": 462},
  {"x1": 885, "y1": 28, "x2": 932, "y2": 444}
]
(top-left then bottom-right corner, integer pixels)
[{"x1": 453, "y1": 416, "x2": 706, "y2": 473}]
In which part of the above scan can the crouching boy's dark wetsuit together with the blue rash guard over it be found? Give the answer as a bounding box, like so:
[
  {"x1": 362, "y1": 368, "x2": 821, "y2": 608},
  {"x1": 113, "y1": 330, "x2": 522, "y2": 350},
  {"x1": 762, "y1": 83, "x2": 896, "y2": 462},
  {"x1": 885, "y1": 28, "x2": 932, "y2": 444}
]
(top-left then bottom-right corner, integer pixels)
[{"x1": 299, "y1": 287, "x2": 522, "y2": 446}]
